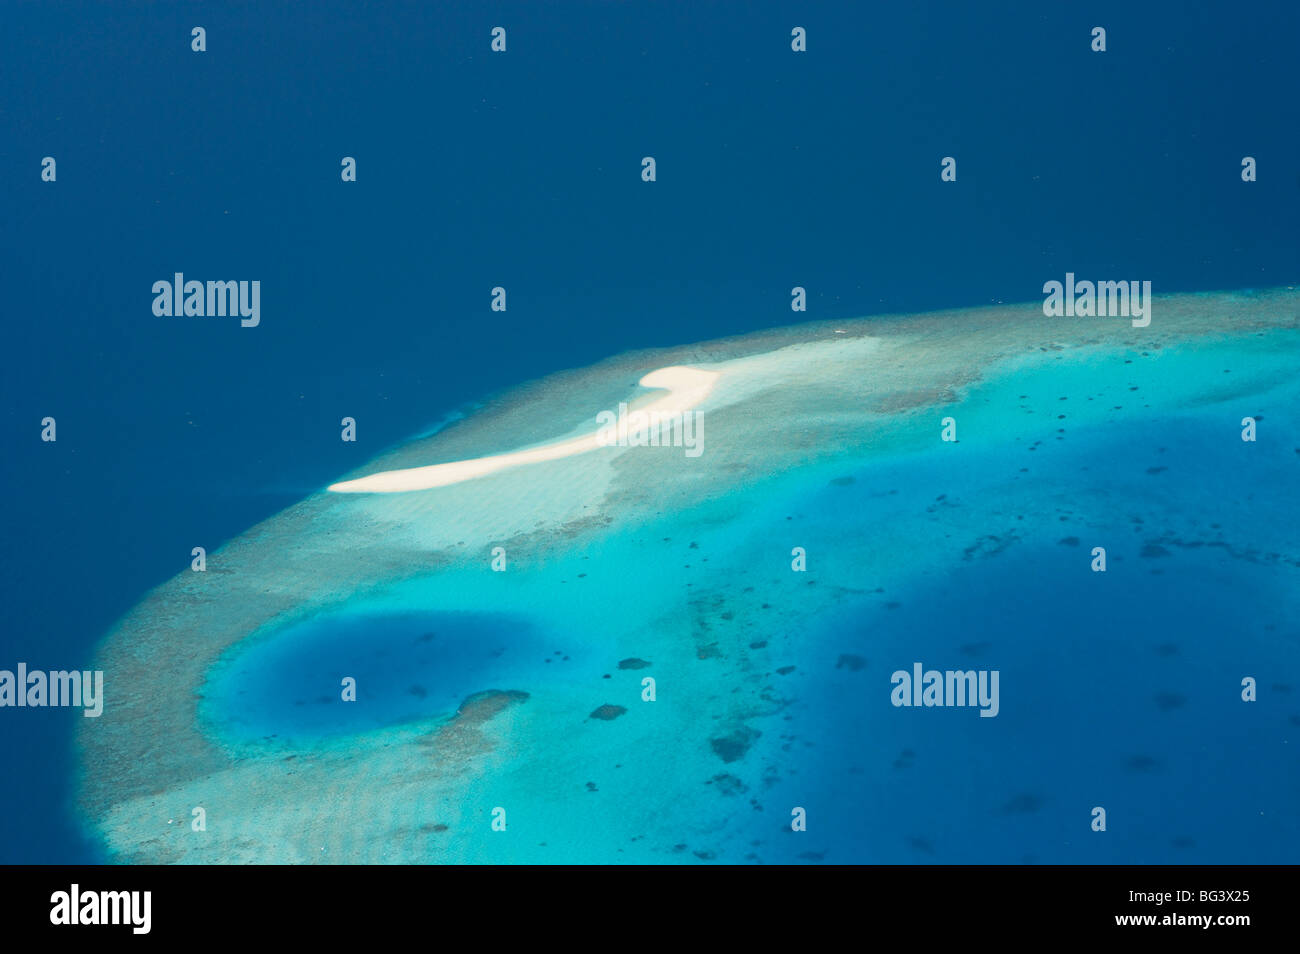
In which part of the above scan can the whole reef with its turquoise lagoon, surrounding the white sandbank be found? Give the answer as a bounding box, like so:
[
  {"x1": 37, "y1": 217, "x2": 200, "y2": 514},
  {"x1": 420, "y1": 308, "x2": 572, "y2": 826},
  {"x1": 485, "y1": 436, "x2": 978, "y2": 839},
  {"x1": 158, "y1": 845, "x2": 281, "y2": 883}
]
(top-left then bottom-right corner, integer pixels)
[{"x1": 83, "y1": 292, "x2": 1300, "y2": 862}]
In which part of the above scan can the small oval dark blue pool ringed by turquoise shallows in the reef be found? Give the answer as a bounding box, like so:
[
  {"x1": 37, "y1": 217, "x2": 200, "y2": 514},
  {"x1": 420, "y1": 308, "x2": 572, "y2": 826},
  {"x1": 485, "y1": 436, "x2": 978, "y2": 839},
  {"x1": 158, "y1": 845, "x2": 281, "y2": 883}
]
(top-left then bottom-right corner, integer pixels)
[{"x1": 203, "y1": 612, "x2": 548, "y2": 741}]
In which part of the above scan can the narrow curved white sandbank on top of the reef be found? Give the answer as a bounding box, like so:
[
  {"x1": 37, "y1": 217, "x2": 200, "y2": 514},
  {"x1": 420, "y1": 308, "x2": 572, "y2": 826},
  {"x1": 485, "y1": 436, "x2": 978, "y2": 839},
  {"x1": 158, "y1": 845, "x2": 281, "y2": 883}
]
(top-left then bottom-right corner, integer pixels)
[{"x1": 329, "y1": 365, "x2": 722, "y2": 494}]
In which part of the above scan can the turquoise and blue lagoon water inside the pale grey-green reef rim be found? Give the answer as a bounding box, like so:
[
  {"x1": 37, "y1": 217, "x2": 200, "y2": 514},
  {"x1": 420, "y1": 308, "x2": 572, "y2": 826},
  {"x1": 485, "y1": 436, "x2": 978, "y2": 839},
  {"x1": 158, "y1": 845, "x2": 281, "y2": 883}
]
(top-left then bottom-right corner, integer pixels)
[{"x1": 81, "y1": 302, "x2": 1300, "y2": 863}]
